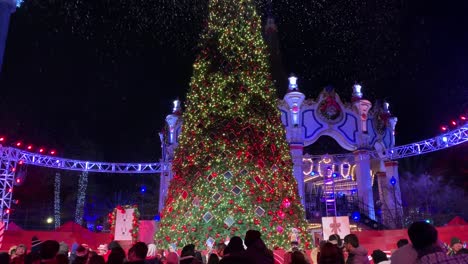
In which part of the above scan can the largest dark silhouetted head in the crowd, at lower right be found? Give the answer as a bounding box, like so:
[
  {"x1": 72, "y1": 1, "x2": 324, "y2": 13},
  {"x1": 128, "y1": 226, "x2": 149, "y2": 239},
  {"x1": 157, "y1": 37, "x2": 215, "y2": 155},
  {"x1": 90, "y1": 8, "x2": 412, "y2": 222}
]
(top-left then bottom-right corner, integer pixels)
[{"x1": 408, "y1": 221, "x2": 437, "y2": 250}]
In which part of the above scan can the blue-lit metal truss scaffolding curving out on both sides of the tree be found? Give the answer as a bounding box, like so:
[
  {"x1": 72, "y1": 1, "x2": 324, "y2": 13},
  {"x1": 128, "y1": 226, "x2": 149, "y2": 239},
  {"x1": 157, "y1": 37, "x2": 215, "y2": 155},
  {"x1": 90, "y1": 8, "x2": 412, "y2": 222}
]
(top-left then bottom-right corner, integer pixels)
[{"x1": 0, "y1": 124, "x2": 468, "y2": 227}]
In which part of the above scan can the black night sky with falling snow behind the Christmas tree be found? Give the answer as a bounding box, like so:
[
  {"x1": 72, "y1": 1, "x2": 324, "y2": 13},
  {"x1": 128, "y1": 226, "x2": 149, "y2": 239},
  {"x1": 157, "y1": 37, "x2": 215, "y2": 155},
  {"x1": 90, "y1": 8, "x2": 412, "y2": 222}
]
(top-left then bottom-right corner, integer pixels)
[{"x1": 0, "y1": 0, "x2": 468, "y2": 223}]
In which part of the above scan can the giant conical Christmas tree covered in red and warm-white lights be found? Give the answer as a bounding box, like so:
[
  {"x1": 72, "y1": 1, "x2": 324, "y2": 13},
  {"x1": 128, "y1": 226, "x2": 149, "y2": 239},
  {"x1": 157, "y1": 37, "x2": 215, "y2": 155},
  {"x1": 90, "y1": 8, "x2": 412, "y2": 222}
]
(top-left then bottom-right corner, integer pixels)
[{"x1": 156, "y1": 0, "x2": 309, "y2": 248}]
